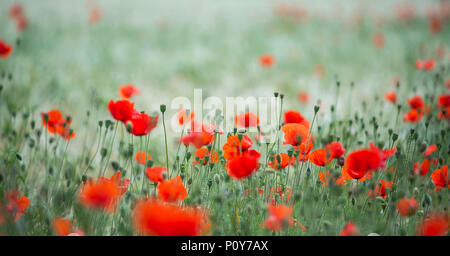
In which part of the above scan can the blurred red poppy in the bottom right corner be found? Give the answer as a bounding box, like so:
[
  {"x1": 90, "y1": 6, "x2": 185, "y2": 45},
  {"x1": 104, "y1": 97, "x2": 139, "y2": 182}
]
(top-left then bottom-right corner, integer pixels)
[{"x1": 417, "y1": 213, "x2": 450, "y2": 236}]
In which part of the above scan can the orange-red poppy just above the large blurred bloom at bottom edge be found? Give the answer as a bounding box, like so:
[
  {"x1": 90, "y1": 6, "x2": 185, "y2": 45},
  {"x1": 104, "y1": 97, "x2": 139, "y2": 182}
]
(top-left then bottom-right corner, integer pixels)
[{"x1": 158, "y1": 176, "x2": 187, "y2": 202}]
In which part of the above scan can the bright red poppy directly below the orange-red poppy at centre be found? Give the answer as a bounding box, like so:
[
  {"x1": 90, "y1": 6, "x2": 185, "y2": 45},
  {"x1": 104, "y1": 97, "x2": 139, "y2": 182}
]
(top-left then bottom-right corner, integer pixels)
[{"x1": 226, "y1": 151, "x2": 259, "y2": 179}]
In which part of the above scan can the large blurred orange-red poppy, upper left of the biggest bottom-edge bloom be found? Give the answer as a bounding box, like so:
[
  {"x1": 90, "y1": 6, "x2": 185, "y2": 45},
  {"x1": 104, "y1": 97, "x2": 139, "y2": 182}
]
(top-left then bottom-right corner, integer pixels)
[{"x1": 78, "y1": 179, "x2": 122, "y2": 213}]
